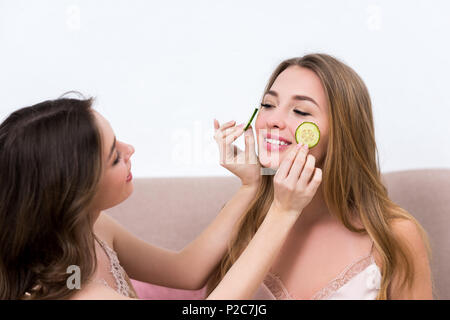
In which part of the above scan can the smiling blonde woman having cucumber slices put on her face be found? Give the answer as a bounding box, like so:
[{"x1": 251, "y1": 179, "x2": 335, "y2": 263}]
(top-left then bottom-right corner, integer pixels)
[{"x1": 208, "y1": 54, "x2": 433, "y2": 299}]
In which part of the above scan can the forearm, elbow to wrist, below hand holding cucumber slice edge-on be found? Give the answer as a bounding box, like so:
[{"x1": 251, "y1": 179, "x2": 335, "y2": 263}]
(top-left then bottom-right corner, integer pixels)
[{"x1": 176, "y1": 185, "x2": 257, "y2": 289}]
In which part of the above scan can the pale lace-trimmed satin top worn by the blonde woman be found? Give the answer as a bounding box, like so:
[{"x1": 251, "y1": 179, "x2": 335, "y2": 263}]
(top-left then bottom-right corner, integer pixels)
[{"x1": 263, "y1": 242, "x2": 381, "y2": 300}]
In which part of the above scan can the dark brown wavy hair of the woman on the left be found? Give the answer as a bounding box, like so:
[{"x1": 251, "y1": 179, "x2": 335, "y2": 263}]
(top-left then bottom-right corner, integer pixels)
[{"x1": 0, "y1": 94, "x2": 102, "y2": 299}]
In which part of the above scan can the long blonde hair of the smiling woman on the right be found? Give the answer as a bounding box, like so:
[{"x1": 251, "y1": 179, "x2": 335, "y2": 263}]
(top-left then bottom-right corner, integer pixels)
[{"x1": 207, "y1": 54, "x2": 431, "y2": 300}]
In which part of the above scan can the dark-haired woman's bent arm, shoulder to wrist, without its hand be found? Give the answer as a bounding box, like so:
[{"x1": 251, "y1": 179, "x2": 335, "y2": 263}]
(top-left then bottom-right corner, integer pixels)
[{"x1": 98, "y1": 185, "x2": 257, "y2": 290}]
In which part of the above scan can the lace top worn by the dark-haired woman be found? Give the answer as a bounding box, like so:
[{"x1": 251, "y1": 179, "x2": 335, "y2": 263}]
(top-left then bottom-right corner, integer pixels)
[{"x1": 94, "y1": 237, "x2": 137, "y2": 298}]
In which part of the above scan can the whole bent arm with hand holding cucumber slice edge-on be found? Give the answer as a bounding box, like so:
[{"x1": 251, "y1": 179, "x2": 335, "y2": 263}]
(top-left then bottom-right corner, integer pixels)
[{"x1": 103, "y1": 120, "x2": 261, "y2": 290}]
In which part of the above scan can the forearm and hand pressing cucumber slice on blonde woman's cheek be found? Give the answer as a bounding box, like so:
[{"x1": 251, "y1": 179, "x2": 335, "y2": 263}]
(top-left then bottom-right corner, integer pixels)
[{"x1": 207, "y1": 142, "x2": 322, "y2": 300}]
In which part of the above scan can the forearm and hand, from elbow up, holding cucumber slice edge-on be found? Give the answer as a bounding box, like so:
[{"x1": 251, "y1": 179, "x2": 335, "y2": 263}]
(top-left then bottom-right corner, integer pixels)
[{"x1": 171, "y1": 119, "x2": 261, "y2": 289}]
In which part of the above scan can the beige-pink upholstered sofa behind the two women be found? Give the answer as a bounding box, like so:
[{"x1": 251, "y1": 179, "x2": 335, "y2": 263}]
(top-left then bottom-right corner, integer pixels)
[{"x1": 107, "y1": 169, "x2": 450, "y2": 299}]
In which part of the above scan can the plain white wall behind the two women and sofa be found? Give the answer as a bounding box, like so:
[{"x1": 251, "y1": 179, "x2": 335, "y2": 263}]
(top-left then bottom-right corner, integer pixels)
[{"x1": 0, "y1": 0, "x2": 450, "y2": 177}]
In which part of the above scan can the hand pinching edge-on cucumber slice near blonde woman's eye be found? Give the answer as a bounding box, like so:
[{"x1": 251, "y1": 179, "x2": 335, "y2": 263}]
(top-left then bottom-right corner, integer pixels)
[{"x1": 214, "y1": 119, "x2": 261, "y2": 187}]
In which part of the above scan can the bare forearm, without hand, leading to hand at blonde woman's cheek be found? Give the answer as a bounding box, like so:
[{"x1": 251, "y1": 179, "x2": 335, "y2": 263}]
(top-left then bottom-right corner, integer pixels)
[{"x1": 207, "y1": 207, "x2": 296, "y2": 300}]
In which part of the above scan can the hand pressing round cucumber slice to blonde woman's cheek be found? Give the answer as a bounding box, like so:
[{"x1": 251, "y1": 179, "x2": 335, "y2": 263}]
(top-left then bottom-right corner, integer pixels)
[{"x1": 270, "y1": 144, "x2": 322, "y2": 220}]
